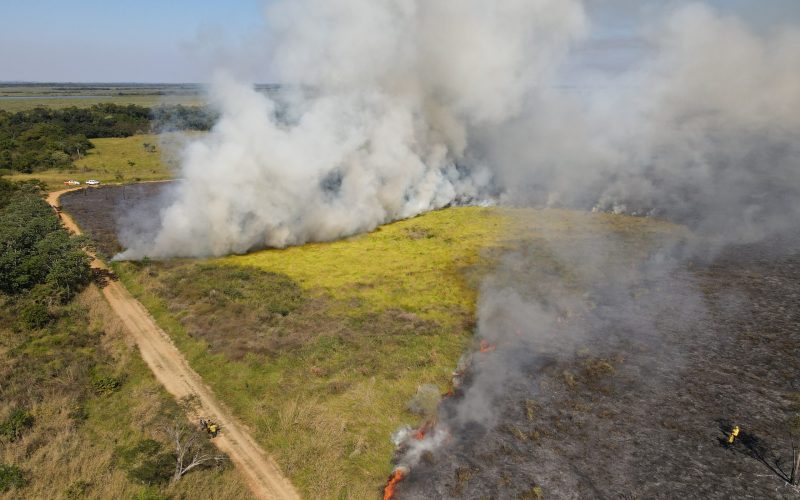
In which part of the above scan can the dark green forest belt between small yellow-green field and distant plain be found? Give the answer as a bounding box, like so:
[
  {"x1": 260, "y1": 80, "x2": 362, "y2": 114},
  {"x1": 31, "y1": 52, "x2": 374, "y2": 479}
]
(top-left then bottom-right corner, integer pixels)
[{"x1": 0, "y1": 104, "x2": 216, "y2": 173}]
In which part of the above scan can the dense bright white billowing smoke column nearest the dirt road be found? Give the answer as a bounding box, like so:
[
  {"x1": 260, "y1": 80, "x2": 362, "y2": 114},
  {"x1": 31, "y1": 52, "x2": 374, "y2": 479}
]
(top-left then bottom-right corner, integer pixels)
[{"x1": 122, "y1": 0, "x2": 586, "y2": 258}]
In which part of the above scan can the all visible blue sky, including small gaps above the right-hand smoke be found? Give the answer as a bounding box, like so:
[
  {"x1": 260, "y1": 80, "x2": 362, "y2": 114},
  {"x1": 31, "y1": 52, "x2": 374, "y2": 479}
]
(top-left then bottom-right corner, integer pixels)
[{"x1": 0, "y1": 0, "x2": 800, "y2": 82}]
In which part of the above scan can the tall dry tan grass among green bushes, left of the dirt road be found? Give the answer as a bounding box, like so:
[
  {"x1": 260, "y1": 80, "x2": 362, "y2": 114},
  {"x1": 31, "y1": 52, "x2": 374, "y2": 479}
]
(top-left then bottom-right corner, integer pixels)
[{"x1": 0, "y1": 286, "x2": 250, "y2": 500}]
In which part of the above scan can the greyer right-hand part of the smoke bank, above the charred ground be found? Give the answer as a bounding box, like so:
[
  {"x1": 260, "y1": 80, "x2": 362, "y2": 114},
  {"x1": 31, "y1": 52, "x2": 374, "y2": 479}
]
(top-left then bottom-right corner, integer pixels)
[{"x1": 485, "y1": 4, "x2": 800, "y2": 246}]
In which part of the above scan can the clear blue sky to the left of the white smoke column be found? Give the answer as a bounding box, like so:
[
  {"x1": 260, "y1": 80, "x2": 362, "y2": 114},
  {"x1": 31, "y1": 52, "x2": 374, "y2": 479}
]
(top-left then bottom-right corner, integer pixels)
[{"x1": 0, "y1": 0, "x2": 264, "y2": 82}]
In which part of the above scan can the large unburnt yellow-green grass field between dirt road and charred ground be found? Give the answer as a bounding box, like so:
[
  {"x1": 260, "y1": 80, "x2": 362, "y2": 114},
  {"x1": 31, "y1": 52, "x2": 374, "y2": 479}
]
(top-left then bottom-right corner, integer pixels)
[{"x1": 111, "y1": 207, "x2": 675, "y2": 499}]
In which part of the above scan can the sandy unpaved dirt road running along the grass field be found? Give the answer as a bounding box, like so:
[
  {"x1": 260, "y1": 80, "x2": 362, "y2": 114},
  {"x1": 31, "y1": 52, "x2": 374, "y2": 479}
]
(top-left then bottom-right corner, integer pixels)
[{"x1": 47, "y1": 188, "x2": 300, "y2": 499}]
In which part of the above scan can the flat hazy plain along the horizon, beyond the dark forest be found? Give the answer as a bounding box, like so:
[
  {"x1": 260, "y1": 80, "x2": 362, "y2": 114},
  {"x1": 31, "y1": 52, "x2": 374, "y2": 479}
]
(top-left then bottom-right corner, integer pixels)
[{"x1": 0, "y1": 84, "x2": 205, "y2": 112}]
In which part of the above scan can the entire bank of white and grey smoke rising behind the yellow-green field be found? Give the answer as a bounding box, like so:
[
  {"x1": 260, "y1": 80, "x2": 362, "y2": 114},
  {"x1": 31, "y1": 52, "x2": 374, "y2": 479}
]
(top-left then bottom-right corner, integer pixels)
[{"x1": 121, "y1": 0, "x2": 800, "y2": 258}]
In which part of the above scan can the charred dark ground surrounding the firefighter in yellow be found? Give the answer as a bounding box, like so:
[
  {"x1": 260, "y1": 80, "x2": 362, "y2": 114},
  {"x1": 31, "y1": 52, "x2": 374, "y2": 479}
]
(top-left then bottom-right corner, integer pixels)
[{"x1": 397, "y1": 242, "x2": 800, "y2": 498}]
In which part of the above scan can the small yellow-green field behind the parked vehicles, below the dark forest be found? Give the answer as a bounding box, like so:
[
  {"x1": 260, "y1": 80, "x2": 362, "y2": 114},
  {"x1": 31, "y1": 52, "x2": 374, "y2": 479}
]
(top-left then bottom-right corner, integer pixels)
[{"x1": 7, "y1": 132, "x2": 192, "y2": 190}]
